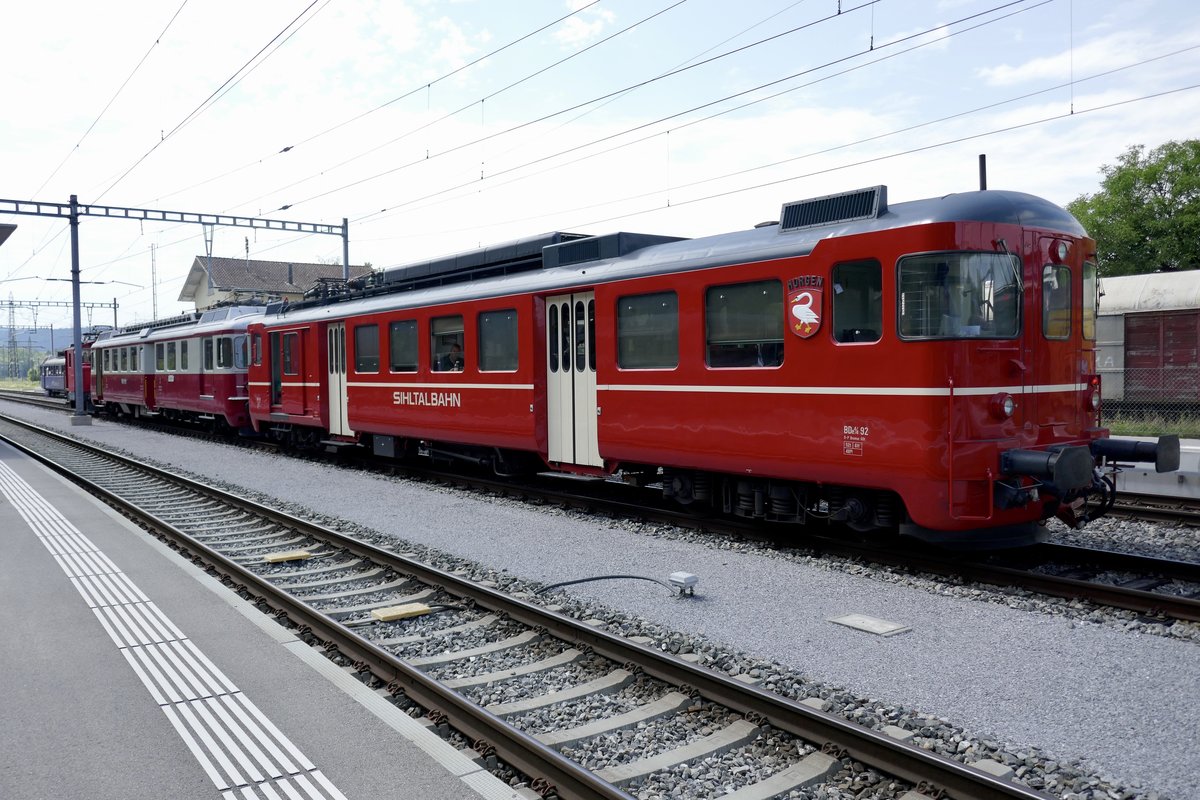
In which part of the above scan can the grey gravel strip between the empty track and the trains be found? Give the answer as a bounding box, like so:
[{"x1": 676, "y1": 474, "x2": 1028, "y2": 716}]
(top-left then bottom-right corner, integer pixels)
[{"x1": 0, "y1": 403, "x2": 1200, "y2": 800}]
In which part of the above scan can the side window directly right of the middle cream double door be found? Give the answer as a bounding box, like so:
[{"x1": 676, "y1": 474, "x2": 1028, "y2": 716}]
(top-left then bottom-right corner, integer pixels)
[{"x1": 619, "y1": 291, "x2": 679, "y2": 371}]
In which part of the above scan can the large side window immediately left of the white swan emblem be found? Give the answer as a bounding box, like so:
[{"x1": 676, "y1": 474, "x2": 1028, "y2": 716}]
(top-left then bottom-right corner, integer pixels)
[{"x1": 704, "y1": 281, "x2": 784, "y2": 367}]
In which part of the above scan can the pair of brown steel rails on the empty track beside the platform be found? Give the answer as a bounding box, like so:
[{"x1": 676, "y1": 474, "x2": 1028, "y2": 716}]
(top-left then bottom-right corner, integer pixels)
[{"x1": 0, "y1": 412, "x2": 1048, "y2": 800}]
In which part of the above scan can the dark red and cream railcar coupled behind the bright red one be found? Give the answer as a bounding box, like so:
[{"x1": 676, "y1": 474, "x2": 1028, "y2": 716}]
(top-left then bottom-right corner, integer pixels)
[{"x1": 92, "y1": 306, "x2": 263, "y2": 429}]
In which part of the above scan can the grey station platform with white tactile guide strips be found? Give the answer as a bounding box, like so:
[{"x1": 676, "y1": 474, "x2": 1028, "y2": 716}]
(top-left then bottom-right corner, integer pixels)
[{"x1": 0, "y1": 443, "x2": 527, "y2": 800}]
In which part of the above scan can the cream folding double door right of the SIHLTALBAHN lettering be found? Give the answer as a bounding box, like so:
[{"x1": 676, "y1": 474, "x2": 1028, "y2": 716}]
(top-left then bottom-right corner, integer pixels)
[{"x1": 546, "y1": 291, "x2": 604, "y2": 467}]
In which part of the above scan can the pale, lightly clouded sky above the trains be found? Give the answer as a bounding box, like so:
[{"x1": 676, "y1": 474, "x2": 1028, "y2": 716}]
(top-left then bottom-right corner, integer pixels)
[{"x1": 0, "y1": 0, "x2": 1200, "y2": 329}]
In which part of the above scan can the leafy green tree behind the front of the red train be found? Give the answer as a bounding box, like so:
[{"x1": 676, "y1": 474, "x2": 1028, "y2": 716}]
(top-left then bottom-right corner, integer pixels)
[{"x1": 1067, "y1": 139, "x2": 1200, "y2": 275}]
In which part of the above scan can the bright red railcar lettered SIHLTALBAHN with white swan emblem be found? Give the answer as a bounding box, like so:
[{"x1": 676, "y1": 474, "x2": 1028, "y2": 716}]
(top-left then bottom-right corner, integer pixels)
[{"x1": 87, "y1": 186, "x2": 1178, "y2": 543}]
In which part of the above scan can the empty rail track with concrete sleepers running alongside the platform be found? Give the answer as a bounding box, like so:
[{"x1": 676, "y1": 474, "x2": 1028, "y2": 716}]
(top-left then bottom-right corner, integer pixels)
[{"x1": 0, "y1": 412, "x2": 1045, "y2": 800}]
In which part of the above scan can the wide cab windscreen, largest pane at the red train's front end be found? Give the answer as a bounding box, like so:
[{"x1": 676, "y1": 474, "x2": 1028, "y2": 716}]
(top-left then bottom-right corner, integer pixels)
[{"x1": 896, "y1": 253, "x2": 1021, "y2": 339}]
